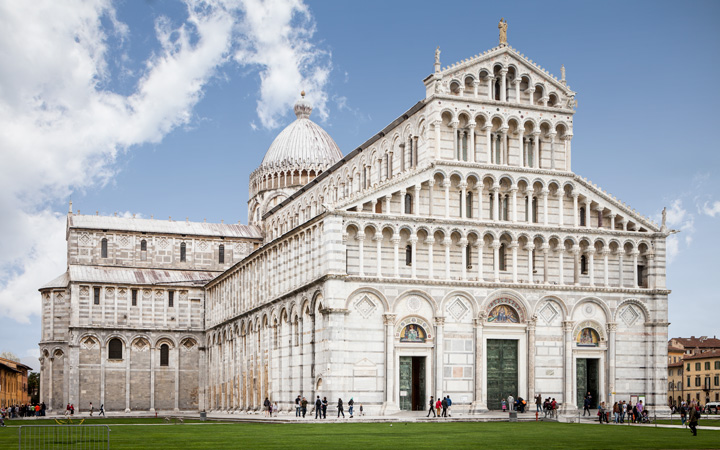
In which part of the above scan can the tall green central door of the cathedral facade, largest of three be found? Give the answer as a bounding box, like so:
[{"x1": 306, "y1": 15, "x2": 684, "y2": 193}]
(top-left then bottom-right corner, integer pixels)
[{"x1": 487, "y1": 339, "x2": 518, "y2": 409}]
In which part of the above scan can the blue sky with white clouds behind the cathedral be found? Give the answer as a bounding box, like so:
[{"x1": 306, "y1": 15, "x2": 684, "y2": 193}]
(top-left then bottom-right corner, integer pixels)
[{"x1": 0, "y1": 0, "x2": 720, "y2": 370}]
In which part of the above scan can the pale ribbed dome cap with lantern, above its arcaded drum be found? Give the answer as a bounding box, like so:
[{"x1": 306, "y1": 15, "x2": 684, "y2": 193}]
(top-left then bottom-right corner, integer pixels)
[{"x1": 260, "y1": 92, "x2": 342, "y2": 170}]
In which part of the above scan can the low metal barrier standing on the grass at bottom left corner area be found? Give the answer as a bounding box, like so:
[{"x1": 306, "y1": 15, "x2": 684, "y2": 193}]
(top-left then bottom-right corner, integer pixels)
[{"x1": 18, "y1": 425, "x2": 110, "y2": 450}]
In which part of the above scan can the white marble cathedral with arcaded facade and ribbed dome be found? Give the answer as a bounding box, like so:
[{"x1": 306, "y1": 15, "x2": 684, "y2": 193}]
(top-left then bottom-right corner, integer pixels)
[{"x1": 39, "y1": 29, "x2": 669, "y2": 414}]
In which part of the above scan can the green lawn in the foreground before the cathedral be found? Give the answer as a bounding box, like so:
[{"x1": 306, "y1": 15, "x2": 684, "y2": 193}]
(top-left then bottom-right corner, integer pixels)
[{"x1": 0, "y1": 419, "x2": 720, "y2": 450}]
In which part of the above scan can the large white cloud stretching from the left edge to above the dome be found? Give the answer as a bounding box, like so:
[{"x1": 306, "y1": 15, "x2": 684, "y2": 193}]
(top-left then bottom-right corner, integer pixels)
[{"x1": 0, "y1": 0, "x2": 330, "y2": 323}]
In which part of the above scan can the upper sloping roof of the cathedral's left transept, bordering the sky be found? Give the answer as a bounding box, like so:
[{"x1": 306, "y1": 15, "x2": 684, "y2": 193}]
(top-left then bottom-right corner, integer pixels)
[{"x1": 68, "y1": 214, "x2": 262, "y2": 239}]
